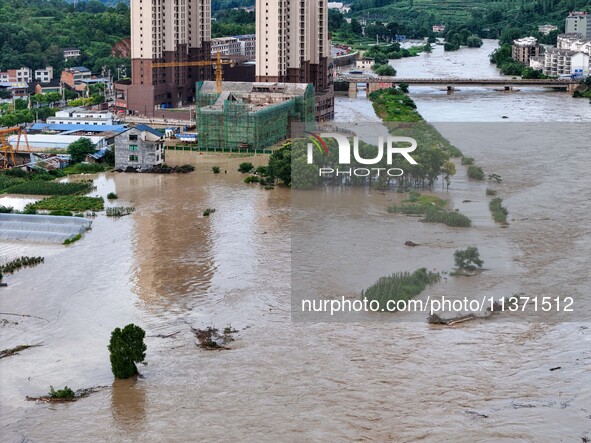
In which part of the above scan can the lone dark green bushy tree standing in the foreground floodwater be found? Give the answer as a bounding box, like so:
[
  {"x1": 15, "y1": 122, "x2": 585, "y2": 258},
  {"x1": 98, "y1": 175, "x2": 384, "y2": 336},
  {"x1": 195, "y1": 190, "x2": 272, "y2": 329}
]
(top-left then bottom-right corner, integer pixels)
[{"x1": 108, "y1": 323, "x2": 147, "y2": 378}]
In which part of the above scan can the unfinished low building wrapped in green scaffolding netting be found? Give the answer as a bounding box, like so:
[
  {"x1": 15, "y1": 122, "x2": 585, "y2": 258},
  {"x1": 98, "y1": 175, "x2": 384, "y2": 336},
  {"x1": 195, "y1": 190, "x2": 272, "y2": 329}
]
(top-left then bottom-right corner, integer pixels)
[{"x1": 196, "y1": 81, "x2": 315, "y2": 151}]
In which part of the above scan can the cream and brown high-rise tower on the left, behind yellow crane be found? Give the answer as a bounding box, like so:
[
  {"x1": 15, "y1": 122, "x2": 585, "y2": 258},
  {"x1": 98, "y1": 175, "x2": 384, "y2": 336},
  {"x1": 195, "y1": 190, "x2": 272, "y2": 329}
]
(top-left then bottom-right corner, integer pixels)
[{"x1": 116, "y1": 0, "x2": 212, "y2": 115}]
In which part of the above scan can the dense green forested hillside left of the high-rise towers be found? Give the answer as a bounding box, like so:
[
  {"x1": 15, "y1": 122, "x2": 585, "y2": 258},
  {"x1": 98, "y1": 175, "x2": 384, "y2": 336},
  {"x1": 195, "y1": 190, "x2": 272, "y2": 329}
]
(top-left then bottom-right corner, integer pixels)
[{"x1": 0, "y1": 0, "x2": 130, "y2": 72}]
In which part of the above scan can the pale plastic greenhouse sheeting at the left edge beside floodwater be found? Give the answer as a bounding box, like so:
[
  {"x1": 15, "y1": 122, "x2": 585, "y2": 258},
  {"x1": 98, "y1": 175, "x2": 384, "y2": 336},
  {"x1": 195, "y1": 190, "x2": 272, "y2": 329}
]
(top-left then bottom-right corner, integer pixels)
[{"x1": 0, "y1": 214, "x2": 92, "y2": 243}]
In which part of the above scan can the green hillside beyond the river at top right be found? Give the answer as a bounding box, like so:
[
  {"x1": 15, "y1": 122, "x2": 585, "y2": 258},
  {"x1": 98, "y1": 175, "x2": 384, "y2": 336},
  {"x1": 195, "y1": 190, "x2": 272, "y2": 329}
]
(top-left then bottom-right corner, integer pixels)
[{"x1": 351, "y1": 0, "x2": 591, "y2": 37}]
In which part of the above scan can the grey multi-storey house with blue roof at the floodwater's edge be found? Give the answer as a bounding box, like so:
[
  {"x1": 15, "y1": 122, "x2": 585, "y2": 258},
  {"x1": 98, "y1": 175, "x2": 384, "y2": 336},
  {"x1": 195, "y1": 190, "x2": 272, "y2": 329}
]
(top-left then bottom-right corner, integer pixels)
[{"x1": 115, "y1": 125, "x2": 164, "y2": 169}]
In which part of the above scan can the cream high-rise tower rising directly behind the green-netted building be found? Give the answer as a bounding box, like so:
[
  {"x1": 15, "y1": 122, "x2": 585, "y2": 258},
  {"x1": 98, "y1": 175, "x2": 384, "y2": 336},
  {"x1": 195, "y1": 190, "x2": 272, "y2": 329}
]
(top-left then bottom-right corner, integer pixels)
[{"x1": 256, "y1": 0, "x2": 334, "y2": 120}]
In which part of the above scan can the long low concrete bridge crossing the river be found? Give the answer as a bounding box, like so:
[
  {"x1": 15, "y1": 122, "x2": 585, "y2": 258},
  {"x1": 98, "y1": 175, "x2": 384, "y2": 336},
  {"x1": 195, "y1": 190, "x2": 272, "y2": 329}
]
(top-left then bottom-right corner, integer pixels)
[{"x1": 335, "y1": 75, "x2": 579, "y2": 96}]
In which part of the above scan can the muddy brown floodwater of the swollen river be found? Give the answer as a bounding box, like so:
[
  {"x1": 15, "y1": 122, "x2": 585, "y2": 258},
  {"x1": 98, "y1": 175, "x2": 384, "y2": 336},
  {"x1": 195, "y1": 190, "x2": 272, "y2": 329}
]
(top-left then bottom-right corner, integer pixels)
[{"x1": 0, "y1": 42, "x2": 591, "y2": 442}]
